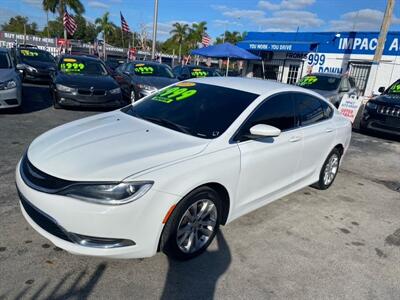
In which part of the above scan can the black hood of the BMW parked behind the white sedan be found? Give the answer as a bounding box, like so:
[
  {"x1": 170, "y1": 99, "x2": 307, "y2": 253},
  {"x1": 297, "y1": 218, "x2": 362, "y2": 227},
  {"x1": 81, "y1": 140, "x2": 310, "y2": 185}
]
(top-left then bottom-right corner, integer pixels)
[{"x1": 55, "y1": 73, "x2": 119, "y2": 90}]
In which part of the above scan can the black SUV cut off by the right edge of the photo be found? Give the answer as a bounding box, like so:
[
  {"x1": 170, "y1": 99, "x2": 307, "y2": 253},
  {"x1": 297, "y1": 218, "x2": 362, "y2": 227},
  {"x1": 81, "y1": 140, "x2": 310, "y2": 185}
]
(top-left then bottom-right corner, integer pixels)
[{"x1": 360, "y1": 79, "x2": 400, "y2": 136}]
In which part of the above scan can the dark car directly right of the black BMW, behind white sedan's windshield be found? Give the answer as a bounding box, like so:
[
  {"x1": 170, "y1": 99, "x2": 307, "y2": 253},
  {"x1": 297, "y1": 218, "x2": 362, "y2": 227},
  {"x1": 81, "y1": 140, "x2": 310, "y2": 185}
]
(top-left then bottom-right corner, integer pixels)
[{"x1": 114, "y1": 61, "x2": 178, "y2": 102}]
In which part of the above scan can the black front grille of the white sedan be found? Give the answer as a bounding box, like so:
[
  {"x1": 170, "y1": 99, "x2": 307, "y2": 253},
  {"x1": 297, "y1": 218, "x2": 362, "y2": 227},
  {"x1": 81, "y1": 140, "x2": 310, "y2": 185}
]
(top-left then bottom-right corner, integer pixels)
[{"x1": 20, "y1": 154, "x2": 75, "y2": 193}]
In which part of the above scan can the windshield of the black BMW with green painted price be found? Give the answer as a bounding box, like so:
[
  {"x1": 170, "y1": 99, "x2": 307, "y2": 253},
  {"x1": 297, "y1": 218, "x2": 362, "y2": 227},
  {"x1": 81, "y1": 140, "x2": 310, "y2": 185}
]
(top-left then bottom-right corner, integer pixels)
[{"x1": 58, "y1": 57, "x2": 108, "y2": 76}]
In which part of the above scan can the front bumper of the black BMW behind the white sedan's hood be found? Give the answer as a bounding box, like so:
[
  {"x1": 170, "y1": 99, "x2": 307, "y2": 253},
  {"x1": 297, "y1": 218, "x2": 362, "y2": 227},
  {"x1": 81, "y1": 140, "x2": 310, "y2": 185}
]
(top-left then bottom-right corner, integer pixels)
[{"x1": 55, "y1": 91, "x2": 127, "y2": 108}]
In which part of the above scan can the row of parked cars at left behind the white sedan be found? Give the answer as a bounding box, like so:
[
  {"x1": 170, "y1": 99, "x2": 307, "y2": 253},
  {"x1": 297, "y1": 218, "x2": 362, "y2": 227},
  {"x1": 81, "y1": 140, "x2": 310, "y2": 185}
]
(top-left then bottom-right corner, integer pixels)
[{"x1": 0, "y1": 45, "x2": 220, "y2": 109}]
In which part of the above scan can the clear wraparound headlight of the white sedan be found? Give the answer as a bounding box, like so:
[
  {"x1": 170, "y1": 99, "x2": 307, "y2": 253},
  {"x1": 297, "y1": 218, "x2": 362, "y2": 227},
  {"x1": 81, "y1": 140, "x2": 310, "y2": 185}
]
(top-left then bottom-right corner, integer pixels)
[{"x1": 59, "y1": 181, "x2": 153, "y2": 205}]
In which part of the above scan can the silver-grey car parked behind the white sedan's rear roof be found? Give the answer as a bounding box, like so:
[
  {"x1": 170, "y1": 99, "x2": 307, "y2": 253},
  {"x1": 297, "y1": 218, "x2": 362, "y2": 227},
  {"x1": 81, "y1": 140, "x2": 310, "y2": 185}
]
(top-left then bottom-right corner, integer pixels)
[{"x1": 297, "y1": 73, "x2": 359, "y2": 107}]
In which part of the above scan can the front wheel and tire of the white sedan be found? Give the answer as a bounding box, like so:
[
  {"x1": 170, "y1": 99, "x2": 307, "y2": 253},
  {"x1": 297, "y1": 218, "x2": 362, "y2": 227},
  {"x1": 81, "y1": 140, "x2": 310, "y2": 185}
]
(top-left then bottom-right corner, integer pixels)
[{"x1": 160, "y1": 186, "x2": 222, "y2": 260}]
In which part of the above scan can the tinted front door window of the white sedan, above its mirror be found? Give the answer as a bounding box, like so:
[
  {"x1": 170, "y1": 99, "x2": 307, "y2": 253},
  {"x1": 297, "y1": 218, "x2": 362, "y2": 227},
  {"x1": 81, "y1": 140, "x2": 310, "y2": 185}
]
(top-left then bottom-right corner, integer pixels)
[{"x1": 238, "y1": 94, "x2": 296, "y2": 141}]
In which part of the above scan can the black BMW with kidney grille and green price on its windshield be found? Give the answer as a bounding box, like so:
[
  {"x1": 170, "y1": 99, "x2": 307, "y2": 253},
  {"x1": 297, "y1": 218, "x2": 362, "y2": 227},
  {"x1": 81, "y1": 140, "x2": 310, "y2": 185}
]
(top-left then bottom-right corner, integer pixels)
[{"x1": 50, "y1": 55, "x2": 128, "y2": 108}]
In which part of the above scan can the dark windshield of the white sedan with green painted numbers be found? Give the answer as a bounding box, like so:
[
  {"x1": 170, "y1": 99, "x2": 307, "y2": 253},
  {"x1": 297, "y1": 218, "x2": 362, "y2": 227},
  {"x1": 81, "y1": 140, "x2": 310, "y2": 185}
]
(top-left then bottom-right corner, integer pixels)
[{"x1": 122, "y1": 82, "x2": 259, "y2": 139}]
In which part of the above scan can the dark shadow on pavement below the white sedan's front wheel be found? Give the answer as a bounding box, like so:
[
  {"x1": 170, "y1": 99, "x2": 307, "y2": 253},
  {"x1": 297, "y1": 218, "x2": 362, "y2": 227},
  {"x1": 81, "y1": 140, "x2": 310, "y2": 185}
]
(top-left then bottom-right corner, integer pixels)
[{"x1": 161, "y1": 231, "x2": 232, "y2": 300}]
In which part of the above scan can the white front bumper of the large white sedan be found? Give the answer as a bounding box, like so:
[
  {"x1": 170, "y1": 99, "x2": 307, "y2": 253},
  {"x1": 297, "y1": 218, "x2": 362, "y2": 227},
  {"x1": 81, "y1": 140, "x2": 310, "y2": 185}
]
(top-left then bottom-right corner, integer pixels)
[{"x1": 16, "y1": 164, "x2": 179, "y2": 258}]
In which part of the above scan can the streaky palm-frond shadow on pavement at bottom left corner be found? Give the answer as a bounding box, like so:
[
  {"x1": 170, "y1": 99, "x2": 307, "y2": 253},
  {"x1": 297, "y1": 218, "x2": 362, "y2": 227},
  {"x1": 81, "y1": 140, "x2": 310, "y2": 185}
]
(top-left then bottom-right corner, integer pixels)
[{"x1": 0, "y1": 263, "x2": 107, "y2": 300}]
